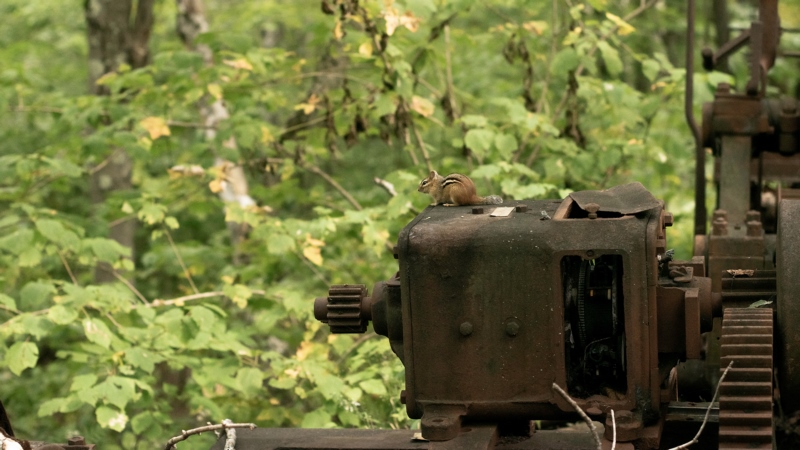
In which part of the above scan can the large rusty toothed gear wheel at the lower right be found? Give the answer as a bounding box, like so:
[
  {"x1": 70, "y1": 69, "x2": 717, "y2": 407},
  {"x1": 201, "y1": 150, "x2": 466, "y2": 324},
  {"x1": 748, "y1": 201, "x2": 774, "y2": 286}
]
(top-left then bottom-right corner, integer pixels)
[{"x1": 719, "y1": 308, "x2": 773, "y2": 450}]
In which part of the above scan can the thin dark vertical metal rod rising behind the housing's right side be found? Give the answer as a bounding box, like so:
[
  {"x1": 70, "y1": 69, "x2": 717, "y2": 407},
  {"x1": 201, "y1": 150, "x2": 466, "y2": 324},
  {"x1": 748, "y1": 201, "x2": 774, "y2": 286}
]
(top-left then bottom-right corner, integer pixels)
[{"x1": 684, "y1": 0, "x2": 706, "y2": 236}]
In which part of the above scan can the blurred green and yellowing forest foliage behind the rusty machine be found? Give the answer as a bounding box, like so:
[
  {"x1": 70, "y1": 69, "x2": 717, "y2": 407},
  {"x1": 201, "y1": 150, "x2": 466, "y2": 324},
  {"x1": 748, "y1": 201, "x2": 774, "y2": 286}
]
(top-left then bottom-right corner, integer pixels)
[{"x1": 0, "y1": 0, "x2": 800, "y2": 449}]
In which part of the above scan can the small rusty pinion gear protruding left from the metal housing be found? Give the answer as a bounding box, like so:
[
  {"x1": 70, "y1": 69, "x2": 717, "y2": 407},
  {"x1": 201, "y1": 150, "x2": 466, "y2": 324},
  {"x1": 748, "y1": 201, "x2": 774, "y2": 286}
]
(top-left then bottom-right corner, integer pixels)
[{"x1": 314, "y1": 284, "x2": 371, "y2": 334}]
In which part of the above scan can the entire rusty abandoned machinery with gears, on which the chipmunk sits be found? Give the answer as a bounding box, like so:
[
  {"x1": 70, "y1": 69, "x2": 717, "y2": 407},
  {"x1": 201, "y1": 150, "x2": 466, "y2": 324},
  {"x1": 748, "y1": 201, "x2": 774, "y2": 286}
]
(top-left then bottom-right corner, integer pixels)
[{"x1": 214, "y1": 0, "x2": 800, "y2": 450}]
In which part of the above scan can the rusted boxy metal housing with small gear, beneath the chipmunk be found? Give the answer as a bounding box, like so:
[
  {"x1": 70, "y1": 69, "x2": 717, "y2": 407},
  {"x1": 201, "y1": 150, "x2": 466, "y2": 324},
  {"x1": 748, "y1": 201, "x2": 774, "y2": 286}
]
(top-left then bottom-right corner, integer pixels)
[{"x1": 314, "y1": 183, "x2": 719, "y2": 448}]
